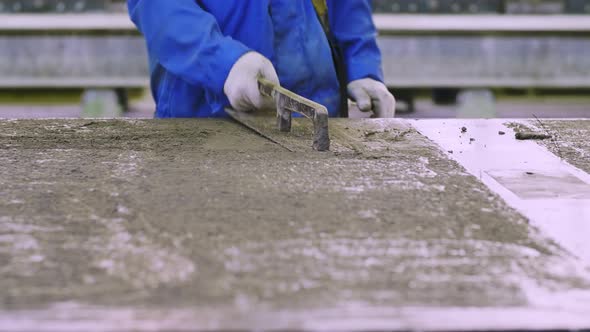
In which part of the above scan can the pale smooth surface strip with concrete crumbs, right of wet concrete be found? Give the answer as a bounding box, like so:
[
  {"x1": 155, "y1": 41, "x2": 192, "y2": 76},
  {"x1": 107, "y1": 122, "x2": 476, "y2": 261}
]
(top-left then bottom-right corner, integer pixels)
[{"x1": 411, "y1": 119, "x2": 590, "y2": 262}]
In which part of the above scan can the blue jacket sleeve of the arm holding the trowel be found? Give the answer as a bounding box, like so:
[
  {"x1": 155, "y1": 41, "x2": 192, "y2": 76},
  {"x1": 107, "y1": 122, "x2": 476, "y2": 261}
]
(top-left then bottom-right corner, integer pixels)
[{"x1": 127, "y1": 0, "x2": 249, "y2": 94}]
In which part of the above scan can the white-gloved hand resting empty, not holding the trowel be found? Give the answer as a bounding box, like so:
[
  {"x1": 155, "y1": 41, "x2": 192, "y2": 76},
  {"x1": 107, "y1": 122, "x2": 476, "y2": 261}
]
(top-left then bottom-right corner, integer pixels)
[{"x1": 348, "y1": 78, "x2": 395, "y2": 118}]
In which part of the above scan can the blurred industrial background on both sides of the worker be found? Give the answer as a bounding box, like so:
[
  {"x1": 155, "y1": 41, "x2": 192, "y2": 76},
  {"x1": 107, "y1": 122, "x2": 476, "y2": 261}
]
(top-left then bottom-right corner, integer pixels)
[{"x1": 0, "y1": 0, "x2": 590, "y2": 118}]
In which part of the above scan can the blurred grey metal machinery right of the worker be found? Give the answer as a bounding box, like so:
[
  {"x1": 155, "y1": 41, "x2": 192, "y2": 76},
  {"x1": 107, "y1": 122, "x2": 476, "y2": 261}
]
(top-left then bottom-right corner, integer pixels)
[{"x1": 373, "y1": 0, "x2": 590, "y2": 111}]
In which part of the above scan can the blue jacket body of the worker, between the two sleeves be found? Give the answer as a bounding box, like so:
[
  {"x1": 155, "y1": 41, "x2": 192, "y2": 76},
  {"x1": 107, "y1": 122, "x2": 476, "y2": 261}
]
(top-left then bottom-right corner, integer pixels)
[{"x1": 152, "y1": 0, "x2": 339, "y2": 117}]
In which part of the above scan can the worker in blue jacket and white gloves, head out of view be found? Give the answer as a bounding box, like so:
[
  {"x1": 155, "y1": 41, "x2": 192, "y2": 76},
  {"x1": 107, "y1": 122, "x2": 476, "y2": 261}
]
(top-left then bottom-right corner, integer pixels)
[{"x1": 127, "y1": 0, "x2": 395, "y2": 118}]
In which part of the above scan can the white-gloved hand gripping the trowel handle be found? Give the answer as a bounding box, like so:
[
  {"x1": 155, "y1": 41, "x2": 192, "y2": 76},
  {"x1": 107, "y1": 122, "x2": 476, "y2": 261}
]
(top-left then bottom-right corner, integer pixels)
[{"x1": 223, "y1": 52, "x2": 279, "y2": 111}]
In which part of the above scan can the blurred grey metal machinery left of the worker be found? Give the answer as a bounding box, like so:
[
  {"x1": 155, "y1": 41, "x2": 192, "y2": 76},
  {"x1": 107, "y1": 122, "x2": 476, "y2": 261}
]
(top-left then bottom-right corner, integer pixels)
[{"x1": 0, "y1": 0, "x2": 148, "y2": 117}]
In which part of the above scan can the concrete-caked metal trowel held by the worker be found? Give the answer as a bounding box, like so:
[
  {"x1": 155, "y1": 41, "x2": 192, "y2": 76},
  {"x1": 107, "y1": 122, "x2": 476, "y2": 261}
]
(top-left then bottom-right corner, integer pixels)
[{"x1": 226, "y1": 77, "x2": 330, "y2": 151}]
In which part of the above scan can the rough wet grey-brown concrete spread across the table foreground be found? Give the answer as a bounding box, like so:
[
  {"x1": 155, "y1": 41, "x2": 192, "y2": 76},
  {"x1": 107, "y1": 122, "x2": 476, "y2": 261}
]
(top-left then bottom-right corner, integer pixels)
[{"x1": 0, "y1": 120, "x2": 590, "y2": 331}]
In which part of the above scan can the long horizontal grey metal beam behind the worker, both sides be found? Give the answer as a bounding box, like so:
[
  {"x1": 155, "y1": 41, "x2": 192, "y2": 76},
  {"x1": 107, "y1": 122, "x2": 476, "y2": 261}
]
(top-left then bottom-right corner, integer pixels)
[{"x1": 0, "y1": 13, "x2": 590, "y2": 88}]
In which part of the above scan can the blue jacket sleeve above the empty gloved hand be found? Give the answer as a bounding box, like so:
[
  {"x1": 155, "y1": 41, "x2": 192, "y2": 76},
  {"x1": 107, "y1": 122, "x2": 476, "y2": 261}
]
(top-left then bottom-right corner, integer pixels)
[{"x1": 327, "y1": 0, "x2": 383, "y2": 82}]
